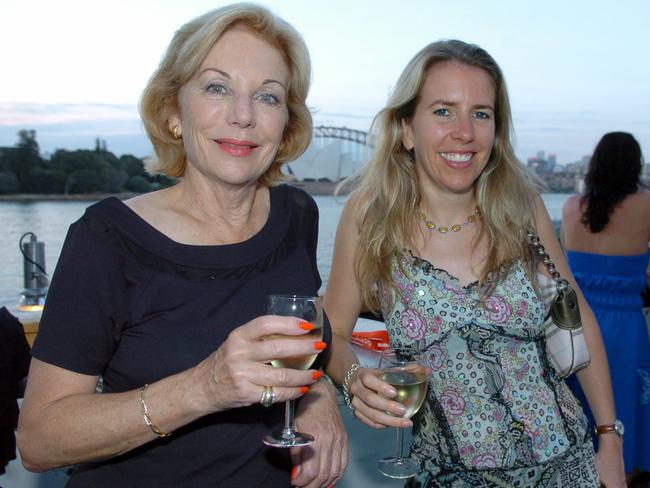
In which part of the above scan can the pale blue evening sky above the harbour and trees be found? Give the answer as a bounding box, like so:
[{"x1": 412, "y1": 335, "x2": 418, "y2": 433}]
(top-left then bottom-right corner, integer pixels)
[{"x1": 0, "y1": 0, "x2": 650, "y2": 164}]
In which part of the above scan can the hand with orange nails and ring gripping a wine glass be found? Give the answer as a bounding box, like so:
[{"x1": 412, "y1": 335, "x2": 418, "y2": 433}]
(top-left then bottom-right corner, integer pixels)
[{"x1": 193, "y1": 315, "x2": 325, "y2": 412}]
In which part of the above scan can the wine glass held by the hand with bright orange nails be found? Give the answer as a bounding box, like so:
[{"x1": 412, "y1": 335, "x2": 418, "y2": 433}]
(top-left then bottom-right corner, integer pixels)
[{"x1": 263, "y1": 295, "x2": 323, "y2": 447}]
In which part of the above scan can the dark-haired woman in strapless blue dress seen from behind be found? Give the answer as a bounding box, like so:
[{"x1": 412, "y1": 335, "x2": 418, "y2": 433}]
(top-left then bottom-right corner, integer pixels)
[{"x1": 562, "y1": 132, "x2": 650, "y2": 482}]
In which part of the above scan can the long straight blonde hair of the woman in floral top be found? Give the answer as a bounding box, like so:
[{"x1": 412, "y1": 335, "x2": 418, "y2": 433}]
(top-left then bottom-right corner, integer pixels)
[{"x1": 352, "y1": 40, "x2": 535, "y2": 311}]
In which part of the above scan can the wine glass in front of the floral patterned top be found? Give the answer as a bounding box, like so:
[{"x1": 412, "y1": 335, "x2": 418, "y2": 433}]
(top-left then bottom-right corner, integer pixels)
[{"x1": 377, "y1": 347, "x2": 431, "y2": 479}]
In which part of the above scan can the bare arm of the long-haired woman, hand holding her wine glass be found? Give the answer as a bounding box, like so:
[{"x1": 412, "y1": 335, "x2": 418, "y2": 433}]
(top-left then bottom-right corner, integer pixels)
[{"x1": 324, "y1": 195, "x2": 412, "y2": 429}]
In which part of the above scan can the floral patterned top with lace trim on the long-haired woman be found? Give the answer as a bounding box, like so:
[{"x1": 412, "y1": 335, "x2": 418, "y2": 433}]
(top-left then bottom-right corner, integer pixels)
[{"x1": 382, "y1": 253, "x2": 587, "y2": 470}]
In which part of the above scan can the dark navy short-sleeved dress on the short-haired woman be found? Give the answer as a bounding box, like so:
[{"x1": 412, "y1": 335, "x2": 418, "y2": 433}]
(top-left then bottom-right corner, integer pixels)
[{"x1": 33, "y1": 186, "x2": 331, "y2": 488}]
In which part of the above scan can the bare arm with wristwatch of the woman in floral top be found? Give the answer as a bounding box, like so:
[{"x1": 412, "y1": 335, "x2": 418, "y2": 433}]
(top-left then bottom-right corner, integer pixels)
[{"x1": 535, "y1": 197, "x2": 625, "y2": 487}]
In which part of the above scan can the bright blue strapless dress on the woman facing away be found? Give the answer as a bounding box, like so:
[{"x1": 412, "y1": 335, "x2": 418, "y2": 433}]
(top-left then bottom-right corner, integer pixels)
[{"x1": 567, "y1": 251, "x2": 650, "y2": 472}]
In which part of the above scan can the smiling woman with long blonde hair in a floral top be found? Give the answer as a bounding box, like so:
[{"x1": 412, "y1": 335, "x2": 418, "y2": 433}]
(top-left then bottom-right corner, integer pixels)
[{"x1": 325, "y1": 41, "x2": 624, "y2": 488}]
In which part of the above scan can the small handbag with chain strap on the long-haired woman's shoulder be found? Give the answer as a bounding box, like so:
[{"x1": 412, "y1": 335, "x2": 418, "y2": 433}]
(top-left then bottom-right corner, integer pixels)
[{"x1": 528, "y1": 228, "x2": 591, "y2": 379}]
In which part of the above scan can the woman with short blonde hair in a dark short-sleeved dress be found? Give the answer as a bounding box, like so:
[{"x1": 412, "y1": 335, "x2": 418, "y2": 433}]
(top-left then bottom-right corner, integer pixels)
[{"x1": 18, "y1": 4, "x2": 347, "y2": 487}]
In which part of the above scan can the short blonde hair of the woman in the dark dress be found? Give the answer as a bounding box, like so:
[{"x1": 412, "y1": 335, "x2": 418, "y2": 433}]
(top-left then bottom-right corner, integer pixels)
[{"x1": 140, "y1": 3, "x2": 312, "y2": 186}]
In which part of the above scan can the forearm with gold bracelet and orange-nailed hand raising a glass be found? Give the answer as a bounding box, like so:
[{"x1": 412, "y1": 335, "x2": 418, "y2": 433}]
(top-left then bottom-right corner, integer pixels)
[{"x1": 18, "y1": 316, "x2": 324, "y2": 471}]
